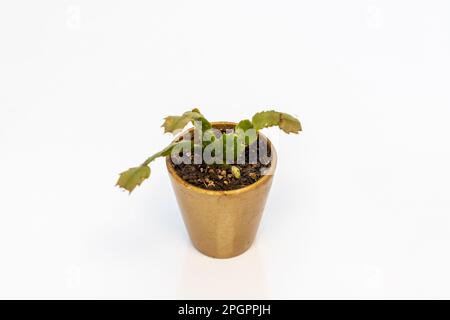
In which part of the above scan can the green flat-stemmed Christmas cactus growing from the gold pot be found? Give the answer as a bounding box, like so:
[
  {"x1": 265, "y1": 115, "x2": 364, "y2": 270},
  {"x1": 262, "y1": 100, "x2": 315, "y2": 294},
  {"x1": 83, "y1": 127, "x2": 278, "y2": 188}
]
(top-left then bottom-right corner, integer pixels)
[{"x1": 116, "y1": 109, "x2": 302, "y2": 193}]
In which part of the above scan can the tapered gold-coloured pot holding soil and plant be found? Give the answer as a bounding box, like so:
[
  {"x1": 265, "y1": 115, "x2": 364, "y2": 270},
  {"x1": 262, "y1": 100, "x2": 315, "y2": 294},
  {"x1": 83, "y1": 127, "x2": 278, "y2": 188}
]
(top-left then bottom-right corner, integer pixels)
[{"x1": 166, "y1": 122, "x2": 277, "y2": 258}]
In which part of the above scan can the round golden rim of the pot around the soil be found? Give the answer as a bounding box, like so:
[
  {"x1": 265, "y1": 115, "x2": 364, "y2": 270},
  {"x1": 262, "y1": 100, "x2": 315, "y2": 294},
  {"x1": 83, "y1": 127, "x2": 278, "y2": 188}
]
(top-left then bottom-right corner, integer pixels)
[{"x1": 166, "y1": 121, "x2": 277, "y2": 196}]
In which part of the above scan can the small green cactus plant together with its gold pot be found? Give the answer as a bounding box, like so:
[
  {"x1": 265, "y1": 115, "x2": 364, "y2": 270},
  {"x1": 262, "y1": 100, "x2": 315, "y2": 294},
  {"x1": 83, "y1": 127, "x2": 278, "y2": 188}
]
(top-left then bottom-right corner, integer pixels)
[{"x1": 117, "y1": 109, "x2": 301, "y2": 258}]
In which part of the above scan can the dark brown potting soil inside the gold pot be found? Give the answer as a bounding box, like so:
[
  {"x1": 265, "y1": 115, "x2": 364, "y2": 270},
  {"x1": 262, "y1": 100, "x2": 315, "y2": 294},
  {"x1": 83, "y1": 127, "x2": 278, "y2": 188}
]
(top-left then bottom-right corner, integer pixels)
[{"x1": 172, "y1": 142, "x2": 271, "y2": 191}]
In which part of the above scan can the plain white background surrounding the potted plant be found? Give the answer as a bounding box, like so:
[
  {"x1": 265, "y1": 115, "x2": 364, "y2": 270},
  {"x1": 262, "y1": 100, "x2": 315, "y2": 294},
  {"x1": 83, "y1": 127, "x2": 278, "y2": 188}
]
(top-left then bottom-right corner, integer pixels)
[{"x1": 0, "y1": 0, "x2": 450, "y2": 299}]
